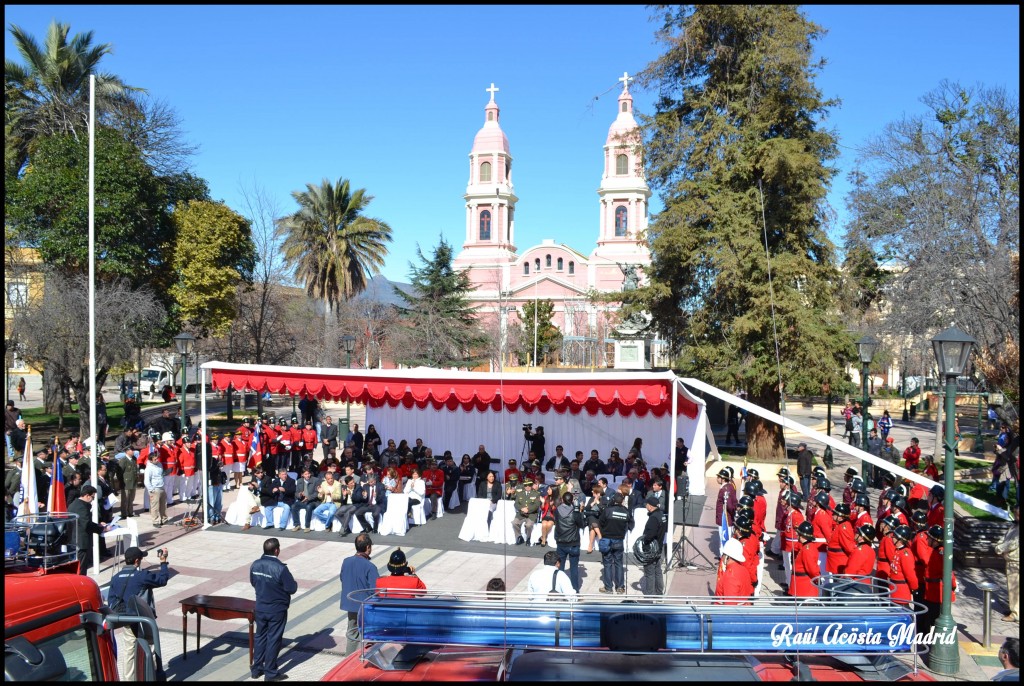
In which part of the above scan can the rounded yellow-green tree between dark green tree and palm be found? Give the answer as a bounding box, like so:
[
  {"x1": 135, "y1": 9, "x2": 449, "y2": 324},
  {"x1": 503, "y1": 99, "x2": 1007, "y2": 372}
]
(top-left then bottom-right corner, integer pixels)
[{"x1": 171, "y1": 201, "x2": 256, "y2": 338}]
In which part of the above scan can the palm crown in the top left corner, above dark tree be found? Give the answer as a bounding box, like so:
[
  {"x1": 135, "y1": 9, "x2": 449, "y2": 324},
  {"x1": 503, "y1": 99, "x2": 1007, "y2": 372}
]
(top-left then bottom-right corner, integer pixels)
[{"x1": 4, "y1": 22, "x2": 142, "y2": 173}]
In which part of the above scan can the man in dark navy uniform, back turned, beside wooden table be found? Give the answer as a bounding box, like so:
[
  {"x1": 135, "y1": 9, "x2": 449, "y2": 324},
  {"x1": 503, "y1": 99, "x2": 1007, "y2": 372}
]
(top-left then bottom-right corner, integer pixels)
[{"x1": 249, "y1": 539, "x2": 299, "y2": 681}]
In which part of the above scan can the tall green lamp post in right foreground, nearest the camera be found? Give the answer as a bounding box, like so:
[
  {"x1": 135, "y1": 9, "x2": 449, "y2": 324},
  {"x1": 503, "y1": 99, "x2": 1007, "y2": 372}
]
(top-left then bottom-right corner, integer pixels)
[{"x1": 928, "y1": 327, "x2": 976, "y2": 675}]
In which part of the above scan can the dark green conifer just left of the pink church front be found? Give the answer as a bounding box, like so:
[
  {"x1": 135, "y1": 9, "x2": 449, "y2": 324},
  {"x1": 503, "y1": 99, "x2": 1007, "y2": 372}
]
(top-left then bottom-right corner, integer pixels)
[{"x1": 395, "y1": 237, "x2": 488, "y2": 368}]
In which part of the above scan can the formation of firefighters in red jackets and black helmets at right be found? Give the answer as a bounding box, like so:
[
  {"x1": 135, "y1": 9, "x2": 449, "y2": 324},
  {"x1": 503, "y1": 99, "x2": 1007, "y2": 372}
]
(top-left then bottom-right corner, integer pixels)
[{"x1": 715, "y1": 456, "x2": 956, "y2": 632}]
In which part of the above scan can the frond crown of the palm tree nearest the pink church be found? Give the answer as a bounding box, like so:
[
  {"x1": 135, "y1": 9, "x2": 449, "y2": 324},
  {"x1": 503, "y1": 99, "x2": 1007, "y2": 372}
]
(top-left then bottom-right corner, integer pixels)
[{"x1": 282, "y1": 178, "x2": 391, "y2": 315}]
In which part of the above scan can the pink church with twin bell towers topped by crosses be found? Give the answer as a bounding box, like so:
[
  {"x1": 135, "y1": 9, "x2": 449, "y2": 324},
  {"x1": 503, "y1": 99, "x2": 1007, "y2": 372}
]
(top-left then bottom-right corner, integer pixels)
[{"x1": 454, "y1": 74, "x2": 650, "y2": 368}]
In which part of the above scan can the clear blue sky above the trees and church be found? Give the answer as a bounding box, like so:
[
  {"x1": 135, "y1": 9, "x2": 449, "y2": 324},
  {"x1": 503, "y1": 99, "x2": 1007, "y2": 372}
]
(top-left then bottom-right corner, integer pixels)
[{"x1": 4, "y1": 5, "x2": 1020, "y2": 281}]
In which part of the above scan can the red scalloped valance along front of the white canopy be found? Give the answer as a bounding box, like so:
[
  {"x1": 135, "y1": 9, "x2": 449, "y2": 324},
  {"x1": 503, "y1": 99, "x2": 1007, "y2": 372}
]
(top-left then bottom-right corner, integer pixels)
[{"x1": 210, "y1": 369, "x2": 697, "y2": 419}]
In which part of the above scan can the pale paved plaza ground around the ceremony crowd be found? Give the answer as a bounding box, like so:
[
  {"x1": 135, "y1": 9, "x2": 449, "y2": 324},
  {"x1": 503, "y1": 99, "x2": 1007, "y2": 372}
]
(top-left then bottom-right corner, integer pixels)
[{"x1": 8, "y1": 376, "x2": 1020, "y2": 681}]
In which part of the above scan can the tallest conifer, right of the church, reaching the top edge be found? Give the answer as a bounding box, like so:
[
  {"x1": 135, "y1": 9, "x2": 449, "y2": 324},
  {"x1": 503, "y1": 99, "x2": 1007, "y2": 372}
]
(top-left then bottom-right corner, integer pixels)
[{"x1": 638, "y1": 5, "x2": 852, "y2": 457}]
